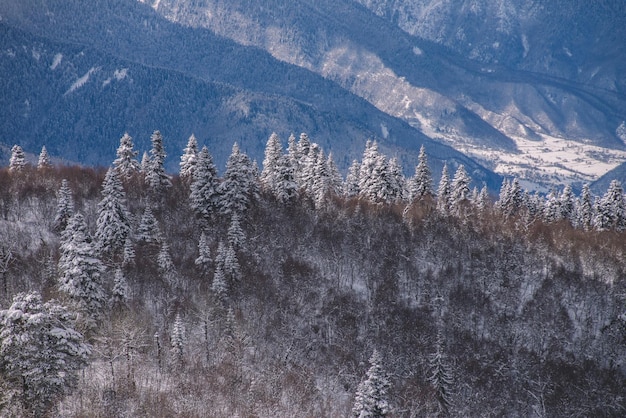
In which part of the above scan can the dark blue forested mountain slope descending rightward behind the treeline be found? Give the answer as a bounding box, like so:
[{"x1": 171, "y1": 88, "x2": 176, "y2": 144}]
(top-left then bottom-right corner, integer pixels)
[{"x1": 0, "y1": 0, "x2": 499, "y2": 188}]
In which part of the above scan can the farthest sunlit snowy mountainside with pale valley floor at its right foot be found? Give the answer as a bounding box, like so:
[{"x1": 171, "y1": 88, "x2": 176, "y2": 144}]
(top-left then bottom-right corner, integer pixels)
[{"x1": 146, "y1": 0, "x2": 626, "y2": 186}]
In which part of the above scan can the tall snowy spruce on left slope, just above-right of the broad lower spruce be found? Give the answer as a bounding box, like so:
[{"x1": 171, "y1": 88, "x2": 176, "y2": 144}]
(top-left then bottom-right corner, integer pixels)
[{"x1": 94, "y1": 168, "x2": 131, "y2": 257}]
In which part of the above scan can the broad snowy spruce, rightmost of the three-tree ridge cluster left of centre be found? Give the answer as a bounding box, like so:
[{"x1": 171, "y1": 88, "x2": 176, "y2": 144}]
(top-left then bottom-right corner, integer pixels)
[{"x1": 219, "y1": 143, "x2": 258, "y2": 216}]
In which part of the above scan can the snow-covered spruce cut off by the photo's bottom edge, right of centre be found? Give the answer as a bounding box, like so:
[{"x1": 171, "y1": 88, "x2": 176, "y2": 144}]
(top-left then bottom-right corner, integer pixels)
[{"x1": 352, "y1": 350, "x2": 391, "y2": 418}]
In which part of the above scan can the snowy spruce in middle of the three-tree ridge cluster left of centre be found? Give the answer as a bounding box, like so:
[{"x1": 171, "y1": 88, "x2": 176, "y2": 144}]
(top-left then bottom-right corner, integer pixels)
[{"x1": 189, "y1": 147, "x2": 219, "y2": 220}]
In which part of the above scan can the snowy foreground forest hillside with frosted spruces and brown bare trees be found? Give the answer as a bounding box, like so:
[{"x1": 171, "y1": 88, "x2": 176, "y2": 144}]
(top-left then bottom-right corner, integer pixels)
[{"x1": 0, "y1": 131, "x2": 626, "y2": 417}]
